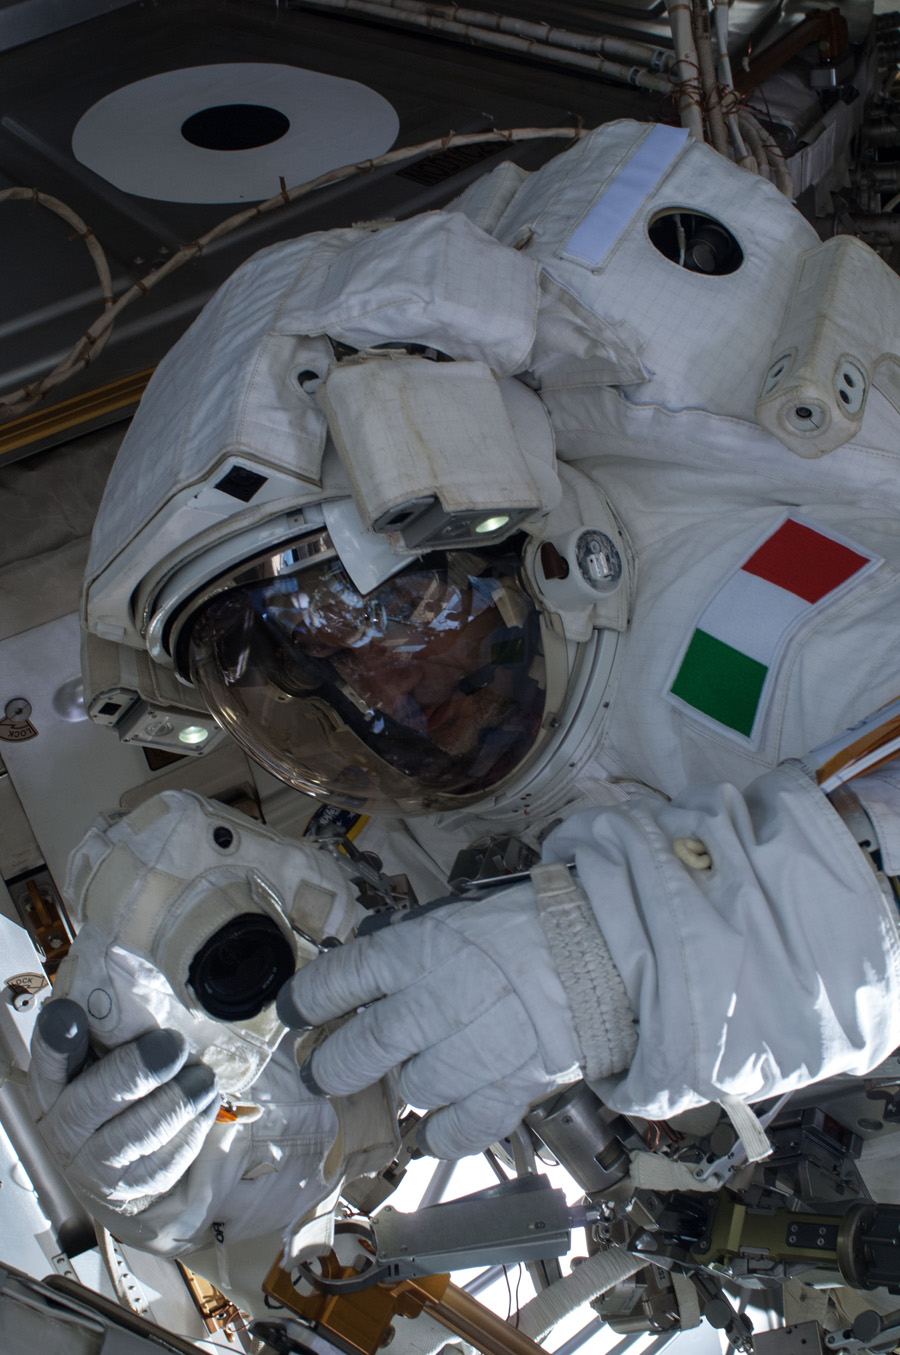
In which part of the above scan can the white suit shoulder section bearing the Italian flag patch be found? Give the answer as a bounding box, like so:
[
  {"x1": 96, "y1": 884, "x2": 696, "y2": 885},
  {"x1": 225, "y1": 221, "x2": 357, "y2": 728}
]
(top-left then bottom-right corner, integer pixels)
[{"x1": 554, "y1": 392, "x2": 900, "y2": 794}]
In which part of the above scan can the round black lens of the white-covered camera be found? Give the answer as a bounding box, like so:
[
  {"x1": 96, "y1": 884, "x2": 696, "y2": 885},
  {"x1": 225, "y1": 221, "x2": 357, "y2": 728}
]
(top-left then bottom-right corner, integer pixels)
[{"x1": 187, "y1": 913, "x2": 294, "y2": 1020}]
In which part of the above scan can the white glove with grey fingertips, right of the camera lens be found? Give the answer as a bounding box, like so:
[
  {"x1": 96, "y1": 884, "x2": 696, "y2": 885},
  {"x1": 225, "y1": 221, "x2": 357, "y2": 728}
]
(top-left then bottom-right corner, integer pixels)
[{"x1": 278, "y1": 883, "x2": 630, "y2": 1159}]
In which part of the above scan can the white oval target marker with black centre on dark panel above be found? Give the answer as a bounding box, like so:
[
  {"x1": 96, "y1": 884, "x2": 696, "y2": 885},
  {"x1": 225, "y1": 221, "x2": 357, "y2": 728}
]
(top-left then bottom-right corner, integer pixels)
[{"x1": 72, "y1": 61, "x2": 400, "y2": 203}]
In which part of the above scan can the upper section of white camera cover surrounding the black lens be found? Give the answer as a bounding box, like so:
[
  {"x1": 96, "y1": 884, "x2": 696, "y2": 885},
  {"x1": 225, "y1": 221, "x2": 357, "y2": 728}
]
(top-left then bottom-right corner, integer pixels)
[{"x1": 54, "y1": 790, "x2": 363, "y2": 1093}]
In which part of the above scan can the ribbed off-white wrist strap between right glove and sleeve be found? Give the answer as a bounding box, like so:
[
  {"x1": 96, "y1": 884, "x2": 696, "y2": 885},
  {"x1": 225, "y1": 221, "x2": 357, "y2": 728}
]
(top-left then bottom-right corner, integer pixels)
[{"x1": 531, "y1": 863, "x2": 637, "y2": 1081}]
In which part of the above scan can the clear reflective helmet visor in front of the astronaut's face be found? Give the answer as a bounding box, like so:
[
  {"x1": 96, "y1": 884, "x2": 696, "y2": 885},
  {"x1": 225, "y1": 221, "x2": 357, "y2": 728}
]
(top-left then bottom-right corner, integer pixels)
[{"x1": 190, "y1": 550, "x2": 545, "y2": 813}]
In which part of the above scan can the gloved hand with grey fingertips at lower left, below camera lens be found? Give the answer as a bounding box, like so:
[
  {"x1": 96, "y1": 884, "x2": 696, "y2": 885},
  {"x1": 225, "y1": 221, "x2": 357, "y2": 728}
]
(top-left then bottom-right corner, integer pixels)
[{"x1": 28, "y1": 997, "x2": 220, "y2": 1214}]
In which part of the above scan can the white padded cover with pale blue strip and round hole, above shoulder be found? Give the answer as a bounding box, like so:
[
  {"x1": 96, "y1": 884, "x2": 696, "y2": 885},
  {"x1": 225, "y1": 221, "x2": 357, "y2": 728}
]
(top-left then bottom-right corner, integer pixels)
[{"x1": 493, "y1": 122, "x2": 819, "y2": 419}]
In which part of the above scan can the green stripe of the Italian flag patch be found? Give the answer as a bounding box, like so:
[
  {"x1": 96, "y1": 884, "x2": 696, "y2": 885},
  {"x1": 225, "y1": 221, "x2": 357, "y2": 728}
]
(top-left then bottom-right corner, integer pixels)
[{"x1": 671, "y1": 630, "x2": 769, "y2": 737}]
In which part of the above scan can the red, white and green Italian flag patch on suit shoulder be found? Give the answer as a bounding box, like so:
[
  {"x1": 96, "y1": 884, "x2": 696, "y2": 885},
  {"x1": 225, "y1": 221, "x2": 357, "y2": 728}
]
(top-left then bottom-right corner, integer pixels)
[{"x1": 670, "y1": 518, "x2": 881, "y2": 738}]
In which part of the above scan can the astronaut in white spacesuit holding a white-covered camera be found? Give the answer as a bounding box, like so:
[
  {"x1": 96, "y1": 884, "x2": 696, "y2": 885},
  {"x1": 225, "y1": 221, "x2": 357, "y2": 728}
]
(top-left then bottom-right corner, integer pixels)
[{"x1": 21, "y1": 123, "x2": 900, "y2": 1289}]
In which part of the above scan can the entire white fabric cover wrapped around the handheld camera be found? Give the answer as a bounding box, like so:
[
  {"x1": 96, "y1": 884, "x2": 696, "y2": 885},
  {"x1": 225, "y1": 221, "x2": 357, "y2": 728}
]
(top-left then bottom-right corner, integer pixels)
[{"x1": 44, "y1": 791, "x2": 397, "y2": 1283}]
